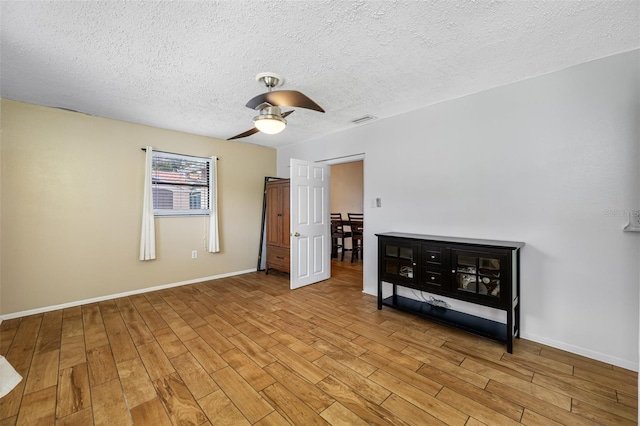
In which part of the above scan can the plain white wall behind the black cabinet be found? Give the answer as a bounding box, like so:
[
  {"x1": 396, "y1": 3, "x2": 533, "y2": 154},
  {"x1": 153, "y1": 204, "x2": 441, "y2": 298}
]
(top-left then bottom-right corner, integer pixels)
[{"x1": 278, "y1": 50, "x2": 640, "y2": 370}]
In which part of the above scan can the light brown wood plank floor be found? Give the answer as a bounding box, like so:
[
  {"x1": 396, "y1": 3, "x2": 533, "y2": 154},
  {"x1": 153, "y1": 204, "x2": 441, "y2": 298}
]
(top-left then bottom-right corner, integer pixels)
[{"x1": 0, "y1": 261, "x2": 638, "y2": 425}]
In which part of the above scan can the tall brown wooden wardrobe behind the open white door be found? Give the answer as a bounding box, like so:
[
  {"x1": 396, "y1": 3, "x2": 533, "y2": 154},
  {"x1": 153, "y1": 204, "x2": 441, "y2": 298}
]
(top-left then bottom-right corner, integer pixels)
[{"x1": 266, "y1": 179, "x2": 290, "y2": 273}]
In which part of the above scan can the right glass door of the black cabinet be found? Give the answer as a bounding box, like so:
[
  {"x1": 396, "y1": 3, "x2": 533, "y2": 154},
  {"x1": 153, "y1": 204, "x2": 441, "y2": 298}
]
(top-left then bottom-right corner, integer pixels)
[{"x1": 451, "y1": 250, "x2": 504, "y2": 299}]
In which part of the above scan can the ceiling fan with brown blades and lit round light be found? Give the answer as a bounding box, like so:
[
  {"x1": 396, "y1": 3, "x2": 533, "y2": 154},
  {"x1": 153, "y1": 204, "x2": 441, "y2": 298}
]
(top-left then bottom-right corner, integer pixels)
[{"x1": 227, "y1": 72, "x2": 324, "y2": 141}]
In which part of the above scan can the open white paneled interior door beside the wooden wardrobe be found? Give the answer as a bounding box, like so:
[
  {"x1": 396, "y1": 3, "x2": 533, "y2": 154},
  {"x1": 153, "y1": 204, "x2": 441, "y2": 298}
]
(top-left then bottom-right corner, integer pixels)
[{"x1": 290, "y1": 158, "x2": 331, "y2": 290}]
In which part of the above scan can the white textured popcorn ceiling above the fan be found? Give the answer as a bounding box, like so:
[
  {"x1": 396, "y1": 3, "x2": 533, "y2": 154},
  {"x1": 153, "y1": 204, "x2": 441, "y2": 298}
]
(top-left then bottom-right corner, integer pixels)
[{"x1": 0, "y1": 0, "x2": 640, "y2": 147}]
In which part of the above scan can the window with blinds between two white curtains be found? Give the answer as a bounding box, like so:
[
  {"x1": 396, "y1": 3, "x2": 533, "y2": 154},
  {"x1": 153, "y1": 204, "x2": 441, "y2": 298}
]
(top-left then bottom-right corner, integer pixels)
[{"x1": 151, "y1": 151, "x2": 212, "y2": 216}]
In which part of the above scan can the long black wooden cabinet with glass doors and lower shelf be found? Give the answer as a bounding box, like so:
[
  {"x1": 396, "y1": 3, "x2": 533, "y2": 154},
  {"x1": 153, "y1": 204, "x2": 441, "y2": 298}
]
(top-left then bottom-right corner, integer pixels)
[{"x1": 376, "y1": 232, "x2": 524, "y2": 353}]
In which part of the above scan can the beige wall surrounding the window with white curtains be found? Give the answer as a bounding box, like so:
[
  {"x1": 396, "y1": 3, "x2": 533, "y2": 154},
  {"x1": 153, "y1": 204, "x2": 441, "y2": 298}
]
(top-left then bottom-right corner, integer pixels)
[{"x1": 0, "y1": 100, "x2": 276, "y2": 315}]
